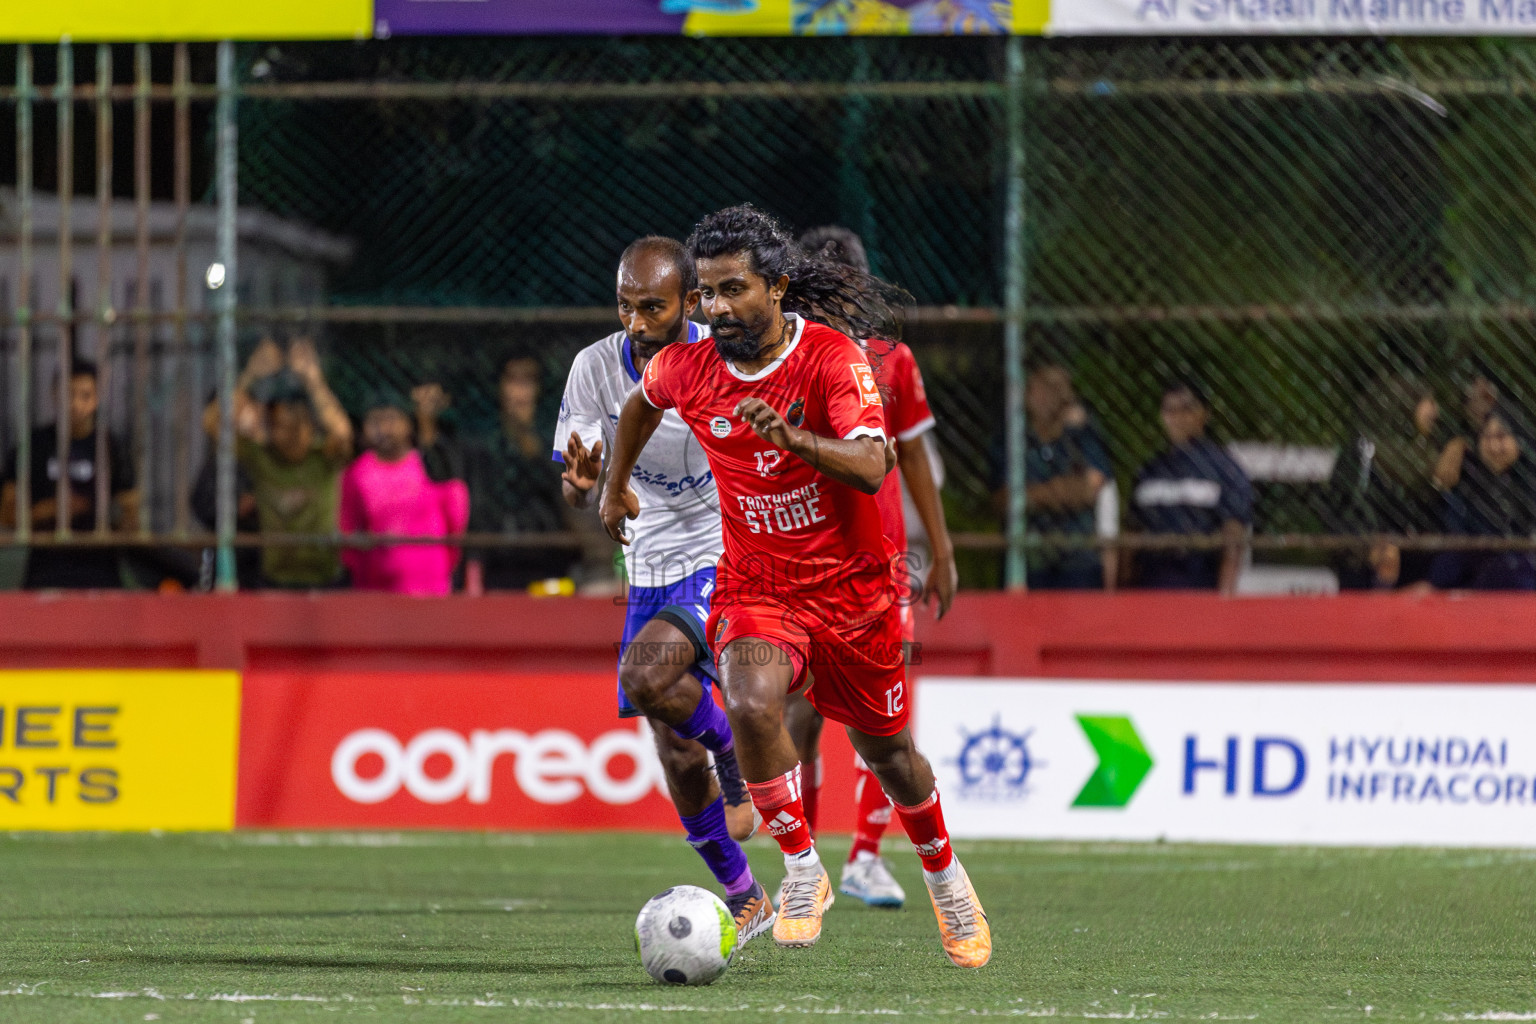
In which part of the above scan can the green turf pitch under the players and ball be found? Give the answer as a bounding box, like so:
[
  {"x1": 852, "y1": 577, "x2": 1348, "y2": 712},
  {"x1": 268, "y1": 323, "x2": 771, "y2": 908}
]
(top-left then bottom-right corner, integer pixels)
[{"x1": 0, "y1": 834, "x2": 1536, "y2": 1024}]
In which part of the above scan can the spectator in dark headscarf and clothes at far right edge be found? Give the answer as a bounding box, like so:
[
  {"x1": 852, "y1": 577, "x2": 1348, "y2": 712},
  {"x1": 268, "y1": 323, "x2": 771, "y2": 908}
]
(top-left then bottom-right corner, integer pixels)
[{"x1": 1430, "y1": 407, "x2": 1536, "y2": 590}]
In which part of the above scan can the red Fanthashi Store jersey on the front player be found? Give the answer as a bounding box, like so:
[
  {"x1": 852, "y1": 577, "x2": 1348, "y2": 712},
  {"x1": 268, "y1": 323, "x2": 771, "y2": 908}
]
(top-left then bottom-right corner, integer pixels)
[{"x1": 641, "y1": 313, "x2": 895, "y2": 628}]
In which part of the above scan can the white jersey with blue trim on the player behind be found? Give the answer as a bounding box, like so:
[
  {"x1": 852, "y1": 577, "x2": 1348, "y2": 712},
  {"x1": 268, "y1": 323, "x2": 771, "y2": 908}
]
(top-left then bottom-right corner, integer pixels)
[{"x1": 554, "y1": 321, "x2": 723, "y2": 586}]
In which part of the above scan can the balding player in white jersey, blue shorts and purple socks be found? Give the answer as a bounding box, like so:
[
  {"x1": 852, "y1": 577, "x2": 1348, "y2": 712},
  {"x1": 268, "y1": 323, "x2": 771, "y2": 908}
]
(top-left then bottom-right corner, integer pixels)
[{"x1": 554, "y1": 236, "x2": 774, "y2": 943}]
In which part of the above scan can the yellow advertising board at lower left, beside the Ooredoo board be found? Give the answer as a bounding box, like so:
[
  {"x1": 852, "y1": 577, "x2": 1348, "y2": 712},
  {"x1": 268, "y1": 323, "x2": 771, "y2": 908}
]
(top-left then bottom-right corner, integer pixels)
[{"x1": 0, "y1": 669, "x2": 240, "y2": 831}]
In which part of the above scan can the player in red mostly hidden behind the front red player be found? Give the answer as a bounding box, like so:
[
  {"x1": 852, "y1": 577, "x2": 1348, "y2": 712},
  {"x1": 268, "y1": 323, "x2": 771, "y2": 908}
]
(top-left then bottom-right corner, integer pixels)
[{"x1": 785, "y1": 224, "x2": 958, "y2": 907}]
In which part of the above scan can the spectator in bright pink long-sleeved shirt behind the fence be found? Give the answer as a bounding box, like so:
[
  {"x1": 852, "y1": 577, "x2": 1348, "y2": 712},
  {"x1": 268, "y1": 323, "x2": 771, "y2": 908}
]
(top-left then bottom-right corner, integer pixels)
[{"x1": 338, "y1": 396, "x2": 470, "y2": 597}]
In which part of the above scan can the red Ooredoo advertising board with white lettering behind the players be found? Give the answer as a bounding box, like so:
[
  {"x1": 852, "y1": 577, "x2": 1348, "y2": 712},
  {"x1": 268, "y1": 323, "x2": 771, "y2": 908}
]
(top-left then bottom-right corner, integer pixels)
[{"x1": 237, "y1": 671, "x2": 852, "y2": 832}]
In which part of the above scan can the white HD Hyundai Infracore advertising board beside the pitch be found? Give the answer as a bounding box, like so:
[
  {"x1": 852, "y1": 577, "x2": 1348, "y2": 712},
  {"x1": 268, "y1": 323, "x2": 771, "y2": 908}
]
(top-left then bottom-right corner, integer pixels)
[{"x1": 917, "y1": 677, "x2": 1536, "y2": 847}]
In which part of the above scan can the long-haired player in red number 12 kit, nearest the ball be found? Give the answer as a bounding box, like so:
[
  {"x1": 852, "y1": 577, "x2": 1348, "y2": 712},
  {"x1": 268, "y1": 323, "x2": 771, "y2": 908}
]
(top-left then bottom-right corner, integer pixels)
[{"x1": 601, "y1": 206, "x2": 992, "y2": 967}]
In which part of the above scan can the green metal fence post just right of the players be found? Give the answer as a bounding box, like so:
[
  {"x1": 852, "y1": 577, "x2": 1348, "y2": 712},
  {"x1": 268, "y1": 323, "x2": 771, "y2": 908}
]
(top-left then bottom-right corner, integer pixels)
[{"x1": 1003, "y1": 35, "x2": 1026, "y2": 590}]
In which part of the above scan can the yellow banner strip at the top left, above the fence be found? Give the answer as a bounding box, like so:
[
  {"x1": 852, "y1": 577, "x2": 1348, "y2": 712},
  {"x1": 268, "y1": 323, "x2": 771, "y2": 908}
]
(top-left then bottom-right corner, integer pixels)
[{"x1": 0, "y1": 0, "x2": 373, "y2": 43}]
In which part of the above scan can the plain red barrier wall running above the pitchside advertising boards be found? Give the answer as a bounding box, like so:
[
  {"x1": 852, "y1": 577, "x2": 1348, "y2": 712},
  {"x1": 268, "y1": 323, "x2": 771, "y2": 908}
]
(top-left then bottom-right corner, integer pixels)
[{"x1": 0, "y1": 593, "x2": 1536, "y2": 682}]
